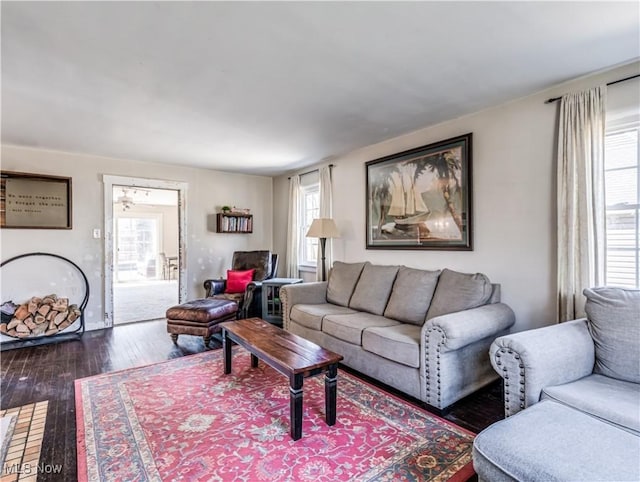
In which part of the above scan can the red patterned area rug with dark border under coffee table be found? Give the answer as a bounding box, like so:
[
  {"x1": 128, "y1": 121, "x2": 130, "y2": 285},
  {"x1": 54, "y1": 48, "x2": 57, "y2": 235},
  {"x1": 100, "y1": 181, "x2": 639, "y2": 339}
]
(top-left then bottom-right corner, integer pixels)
[{"x1": 75, "y1": 347, "x2": 474, "y2": 482}]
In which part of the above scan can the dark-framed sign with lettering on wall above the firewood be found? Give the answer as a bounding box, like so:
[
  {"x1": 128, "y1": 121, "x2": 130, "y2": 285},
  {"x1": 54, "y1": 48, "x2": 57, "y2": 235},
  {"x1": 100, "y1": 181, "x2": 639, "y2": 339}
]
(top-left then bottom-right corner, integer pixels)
[{"x1": 0, "y1": 171, "x2": 72, "y2": 229}]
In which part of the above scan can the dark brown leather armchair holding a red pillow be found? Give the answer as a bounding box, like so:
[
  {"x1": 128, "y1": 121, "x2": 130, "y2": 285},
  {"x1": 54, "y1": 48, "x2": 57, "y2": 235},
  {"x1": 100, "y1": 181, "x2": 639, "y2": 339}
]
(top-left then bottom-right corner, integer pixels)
[{"x1": 204, "y1": 250, "x2": 278, "y2": 318}]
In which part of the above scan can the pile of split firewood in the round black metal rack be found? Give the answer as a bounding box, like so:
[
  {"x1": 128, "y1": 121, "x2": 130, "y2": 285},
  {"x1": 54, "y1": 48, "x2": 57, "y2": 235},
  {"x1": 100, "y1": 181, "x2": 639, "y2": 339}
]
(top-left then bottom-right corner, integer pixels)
[{"x1": 0, "y1": 295, "x2": 81, "y2": 338}]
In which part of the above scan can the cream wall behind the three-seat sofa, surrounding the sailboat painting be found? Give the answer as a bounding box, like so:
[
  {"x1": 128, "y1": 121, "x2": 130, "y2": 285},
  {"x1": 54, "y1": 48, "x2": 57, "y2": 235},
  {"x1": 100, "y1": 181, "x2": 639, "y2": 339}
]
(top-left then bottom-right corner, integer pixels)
[{"x1": 274, "y1": 62, "x2": 640, "y2": 331}]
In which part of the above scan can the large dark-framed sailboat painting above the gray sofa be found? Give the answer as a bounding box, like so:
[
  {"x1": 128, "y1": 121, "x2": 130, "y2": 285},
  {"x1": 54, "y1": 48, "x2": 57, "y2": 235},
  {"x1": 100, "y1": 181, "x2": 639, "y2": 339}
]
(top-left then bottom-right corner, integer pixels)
[{"x1": 366, "y1": 134, "x2": 473, "y2": 251}]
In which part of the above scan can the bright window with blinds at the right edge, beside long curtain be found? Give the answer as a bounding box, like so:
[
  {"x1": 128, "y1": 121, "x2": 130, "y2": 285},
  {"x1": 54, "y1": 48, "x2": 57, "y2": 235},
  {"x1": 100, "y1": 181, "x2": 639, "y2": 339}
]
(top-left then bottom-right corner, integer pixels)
[{"x1": 605, "y1": 123, "x2": 640, "y2": 288}]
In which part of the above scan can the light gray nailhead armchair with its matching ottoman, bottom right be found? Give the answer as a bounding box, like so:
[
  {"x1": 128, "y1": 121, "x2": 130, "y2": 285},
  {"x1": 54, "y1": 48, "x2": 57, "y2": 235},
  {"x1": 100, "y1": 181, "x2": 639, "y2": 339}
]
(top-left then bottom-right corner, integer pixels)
[{"x1": 473, "y1": 287, "x2": 640, "y2": 481}]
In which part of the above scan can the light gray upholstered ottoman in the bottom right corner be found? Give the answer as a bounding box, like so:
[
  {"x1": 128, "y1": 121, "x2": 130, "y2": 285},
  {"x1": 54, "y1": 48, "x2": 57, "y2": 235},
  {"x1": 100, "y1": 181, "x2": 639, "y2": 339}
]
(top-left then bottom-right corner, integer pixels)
[{"x1": 473, "y1": 400, "x2": 640, "y2": 482}]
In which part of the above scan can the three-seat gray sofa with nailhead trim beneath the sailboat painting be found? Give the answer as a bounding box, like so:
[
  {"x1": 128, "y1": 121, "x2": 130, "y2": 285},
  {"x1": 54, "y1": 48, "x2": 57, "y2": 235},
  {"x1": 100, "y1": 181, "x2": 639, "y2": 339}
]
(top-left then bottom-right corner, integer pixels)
[{"x1": 280, "y1": 262, "x2": 515, "y2": 410}]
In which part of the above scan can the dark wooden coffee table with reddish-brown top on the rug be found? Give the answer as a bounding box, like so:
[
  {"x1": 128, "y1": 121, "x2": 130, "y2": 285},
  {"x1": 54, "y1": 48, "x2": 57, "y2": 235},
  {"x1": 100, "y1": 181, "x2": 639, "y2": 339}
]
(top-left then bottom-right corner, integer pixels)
[{"x1": 220, "y1": 318, "x2": 343, "y2": 440}]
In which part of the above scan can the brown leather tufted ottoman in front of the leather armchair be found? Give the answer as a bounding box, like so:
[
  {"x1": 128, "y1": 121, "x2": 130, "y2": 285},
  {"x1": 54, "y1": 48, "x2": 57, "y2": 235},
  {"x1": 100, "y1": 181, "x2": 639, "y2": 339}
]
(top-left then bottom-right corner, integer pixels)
[{"x1": 166, "y1": 298, "x2": 238, "y2": 346}]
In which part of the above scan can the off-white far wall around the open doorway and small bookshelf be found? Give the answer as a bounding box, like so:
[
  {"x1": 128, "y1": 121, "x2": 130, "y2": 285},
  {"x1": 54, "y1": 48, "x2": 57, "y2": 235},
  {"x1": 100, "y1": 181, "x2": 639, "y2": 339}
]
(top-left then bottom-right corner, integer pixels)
[{"x1": 0, "y1": 146, "x2": 273, "y2": 329}]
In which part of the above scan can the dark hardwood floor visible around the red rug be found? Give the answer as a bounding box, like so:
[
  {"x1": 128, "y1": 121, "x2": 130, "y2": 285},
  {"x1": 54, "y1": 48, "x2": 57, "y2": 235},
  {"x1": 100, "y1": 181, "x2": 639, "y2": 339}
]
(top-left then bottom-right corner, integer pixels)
[{"x1": 0, "y1": 320, "x2": 503, "y2": 482}]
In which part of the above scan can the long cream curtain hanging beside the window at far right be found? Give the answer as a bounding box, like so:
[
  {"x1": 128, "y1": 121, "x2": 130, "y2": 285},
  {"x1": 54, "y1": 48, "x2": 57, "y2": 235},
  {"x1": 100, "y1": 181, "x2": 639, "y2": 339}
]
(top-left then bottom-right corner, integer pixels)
[{"x1": 557, "y1": 86, "x2": 607, "y2": 322}]
